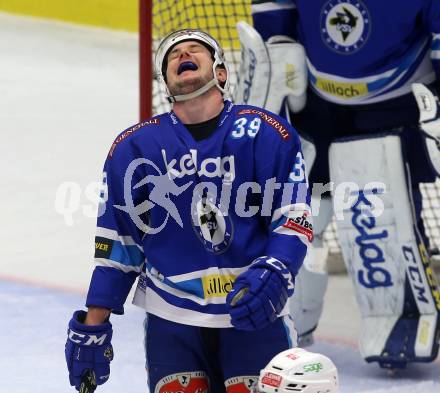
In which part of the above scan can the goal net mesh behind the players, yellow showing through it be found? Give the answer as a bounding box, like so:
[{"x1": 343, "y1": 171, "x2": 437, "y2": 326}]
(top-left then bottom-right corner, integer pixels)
[{"x1": 141, "y1": 0, "x2": 440, "y2": 259}]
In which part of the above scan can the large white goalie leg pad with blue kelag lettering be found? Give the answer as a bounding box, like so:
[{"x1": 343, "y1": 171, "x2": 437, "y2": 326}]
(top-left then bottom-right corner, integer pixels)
[{"x1": 329, "y1": 134, "x2": 440, "y2": 367}]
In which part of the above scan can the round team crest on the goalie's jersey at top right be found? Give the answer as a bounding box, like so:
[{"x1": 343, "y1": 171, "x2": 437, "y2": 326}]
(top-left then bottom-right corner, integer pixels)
[{"x1": 320, "y1": 0, "x2": 371, "y2": 54}]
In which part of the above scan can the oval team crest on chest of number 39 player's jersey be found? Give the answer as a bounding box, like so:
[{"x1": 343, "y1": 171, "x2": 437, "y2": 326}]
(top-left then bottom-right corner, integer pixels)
[{"x1": 191, "y1": 193, "x2": 233, "y2": 254}]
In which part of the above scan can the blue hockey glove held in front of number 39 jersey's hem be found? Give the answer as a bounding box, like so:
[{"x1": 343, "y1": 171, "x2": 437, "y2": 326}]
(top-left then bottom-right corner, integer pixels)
[{"x1": 226, "y1": 256, "x2": 294, "y2": 330}]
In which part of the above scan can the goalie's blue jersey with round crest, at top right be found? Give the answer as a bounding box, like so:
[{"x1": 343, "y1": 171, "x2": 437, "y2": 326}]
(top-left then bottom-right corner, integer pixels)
[{"x1": 253, "y1": 0, "x2": 440, "y2": 105}]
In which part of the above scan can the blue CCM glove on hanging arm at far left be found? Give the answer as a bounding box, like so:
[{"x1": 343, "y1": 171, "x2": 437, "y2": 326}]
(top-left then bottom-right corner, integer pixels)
[{"x1": 65, "y1": 311, "x2": 113, "y2": 390}]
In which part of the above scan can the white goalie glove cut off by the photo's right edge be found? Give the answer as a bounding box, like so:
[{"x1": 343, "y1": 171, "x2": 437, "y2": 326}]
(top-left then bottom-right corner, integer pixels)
[{"x1": 412, "y1": 83, "x2": 440, "y2": 176}]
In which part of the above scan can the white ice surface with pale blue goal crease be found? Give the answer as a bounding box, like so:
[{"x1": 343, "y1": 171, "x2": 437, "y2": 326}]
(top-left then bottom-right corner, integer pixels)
[{"x1": 0, "y1": 13, "x2": 440, "y2": 393}]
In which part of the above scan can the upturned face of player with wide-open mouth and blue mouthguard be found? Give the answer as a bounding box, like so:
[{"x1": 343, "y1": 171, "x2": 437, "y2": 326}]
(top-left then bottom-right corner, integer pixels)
[{"x1": 167, "y1": 41, "x2": 223, "y2": 95}]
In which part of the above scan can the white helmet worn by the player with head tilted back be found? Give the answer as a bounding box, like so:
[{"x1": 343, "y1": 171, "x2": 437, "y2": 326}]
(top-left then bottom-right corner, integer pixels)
[{"x1": 154, "y1": 29, "x2": 229, "y2": 102}]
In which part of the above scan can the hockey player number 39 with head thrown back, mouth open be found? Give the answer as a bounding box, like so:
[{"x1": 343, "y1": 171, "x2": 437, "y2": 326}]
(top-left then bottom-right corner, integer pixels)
[{"x1": 65, "y1": 30, "x2": 313, "y2": 393}]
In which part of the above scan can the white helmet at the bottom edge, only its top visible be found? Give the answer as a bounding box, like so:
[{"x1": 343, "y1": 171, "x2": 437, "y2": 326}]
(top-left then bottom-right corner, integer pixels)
[{"x1": 258, "y1": 348, "x2": 339, "y2": 393}]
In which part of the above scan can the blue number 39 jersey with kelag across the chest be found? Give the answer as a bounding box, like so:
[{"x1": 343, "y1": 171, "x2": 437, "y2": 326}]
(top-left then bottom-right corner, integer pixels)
[{"x1": 86, "y1": 101, "x2": 313, "y2": 327}]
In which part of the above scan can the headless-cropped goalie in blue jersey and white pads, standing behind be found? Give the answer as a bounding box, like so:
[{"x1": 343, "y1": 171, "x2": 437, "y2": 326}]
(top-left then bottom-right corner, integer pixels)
[{"x1": 236, "y1": 0, "x2": 440, "y2": 368}]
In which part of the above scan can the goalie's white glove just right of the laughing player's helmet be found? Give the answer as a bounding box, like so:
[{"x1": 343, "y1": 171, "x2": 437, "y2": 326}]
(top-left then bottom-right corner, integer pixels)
[{"x1": 234, "y1": 21, "x2": 307, "y2": 114}]
